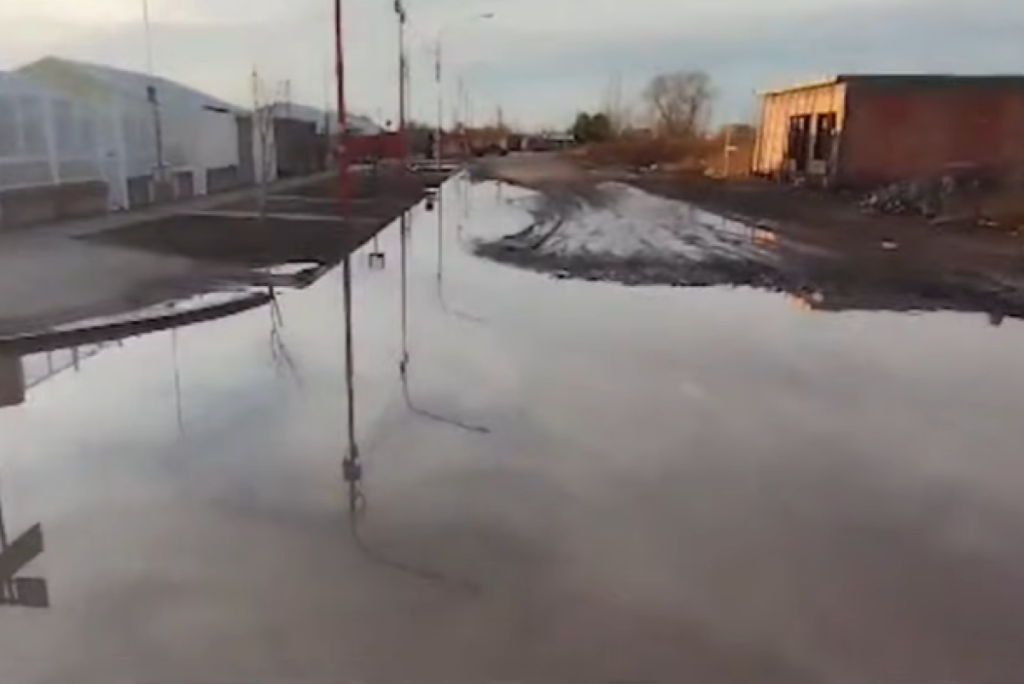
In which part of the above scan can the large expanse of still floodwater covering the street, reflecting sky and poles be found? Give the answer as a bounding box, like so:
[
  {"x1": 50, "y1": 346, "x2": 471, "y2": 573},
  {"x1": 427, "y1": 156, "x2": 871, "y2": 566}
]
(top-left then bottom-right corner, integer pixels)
[{"x1": 0, "y1": 180, "x2": 1024, "y2": 684}]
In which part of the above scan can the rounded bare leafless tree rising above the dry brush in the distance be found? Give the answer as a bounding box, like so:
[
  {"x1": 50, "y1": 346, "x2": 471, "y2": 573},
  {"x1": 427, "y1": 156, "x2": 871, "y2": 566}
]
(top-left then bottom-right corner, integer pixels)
[{"x1": 644, "y1": 71, "x2": 714, "y2": 137}]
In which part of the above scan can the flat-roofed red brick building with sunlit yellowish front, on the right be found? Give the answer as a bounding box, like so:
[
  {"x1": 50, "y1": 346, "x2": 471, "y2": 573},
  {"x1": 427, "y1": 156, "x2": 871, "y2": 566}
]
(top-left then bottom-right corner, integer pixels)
[{"x1": 753, "y1": 75, "x2": 1024, "y2": 185}]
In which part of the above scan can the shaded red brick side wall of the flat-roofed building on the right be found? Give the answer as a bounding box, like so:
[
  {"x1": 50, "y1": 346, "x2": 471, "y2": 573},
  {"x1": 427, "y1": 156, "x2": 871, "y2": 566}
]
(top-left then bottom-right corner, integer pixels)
[{"x1": 841, "y1": 85, "x2": 1024, "y2": 184}]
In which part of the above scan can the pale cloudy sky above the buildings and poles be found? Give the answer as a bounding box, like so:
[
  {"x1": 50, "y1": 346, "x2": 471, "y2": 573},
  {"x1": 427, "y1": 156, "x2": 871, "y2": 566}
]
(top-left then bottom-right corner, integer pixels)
[{"x1": 0, "y1": 0, "x2": 1024, "y2": 129}]
